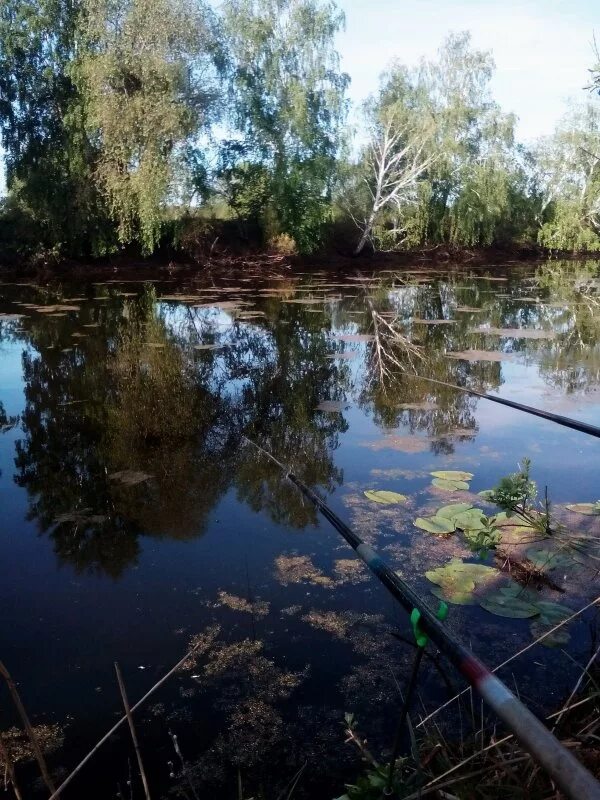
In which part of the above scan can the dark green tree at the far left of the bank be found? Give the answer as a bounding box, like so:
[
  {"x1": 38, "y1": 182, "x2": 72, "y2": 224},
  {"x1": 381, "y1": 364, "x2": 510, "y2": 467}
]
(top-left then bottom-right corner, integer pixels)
[{"x1": 0, "y1": 0, "x2": 110, "y2": 254}]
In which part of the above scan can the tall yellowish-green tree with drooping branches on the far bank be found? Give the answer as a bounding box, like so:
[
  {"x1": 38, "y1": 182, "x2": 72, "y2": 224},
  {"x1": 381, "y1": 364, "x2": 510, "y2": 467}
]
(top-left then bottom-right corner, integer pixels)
[{"x1": 76, "y1": 0, "x2": 220, "y2": 252}]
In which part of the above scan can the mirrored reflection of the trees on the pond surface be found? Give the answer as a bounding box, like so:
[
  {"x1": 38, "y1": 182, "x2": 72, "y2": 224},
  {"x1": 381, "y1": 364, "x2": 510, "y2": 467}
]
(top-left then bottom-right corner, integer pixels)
[{"x1": 0, "y1": 262, "x2": 600, "y2": 577}]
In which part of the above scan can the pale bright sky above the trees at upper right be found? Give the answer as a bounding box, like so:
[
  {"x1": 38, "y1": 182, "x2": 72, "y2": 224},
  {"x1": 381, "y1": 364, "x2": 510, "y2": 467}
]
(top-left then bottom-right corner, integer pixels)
[{"x1": 0, "y1": 0, "x2": 600, "y2": 195}]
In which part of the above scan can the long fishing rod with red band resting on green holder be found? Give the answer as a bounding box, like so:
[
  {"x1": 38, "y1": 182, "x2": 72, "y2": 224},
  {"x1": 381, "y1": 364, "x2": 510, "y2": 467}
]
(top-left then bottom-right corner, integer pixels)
[{"x1": 242, "y1": 436, "x2": 600, "y2": 800}]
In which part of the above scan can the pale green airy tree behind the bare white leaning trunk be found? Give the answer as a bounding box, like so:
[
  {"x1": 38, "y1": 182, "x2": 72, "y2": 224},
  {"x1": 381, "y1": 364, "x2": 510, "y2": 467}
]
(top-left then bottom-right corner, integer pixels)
[{"x1": 354, "y1": 33, "x2": 519, "y2": 246}]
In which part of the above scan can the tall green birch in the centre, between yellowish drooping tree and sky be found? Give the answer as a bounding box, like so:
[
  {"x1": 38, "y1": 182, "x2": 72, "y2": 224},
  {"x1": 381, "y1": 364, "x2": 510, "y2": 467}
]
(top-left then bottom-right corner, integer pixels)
[{"x1": 223, "y1": 0, "x2": 348, "y2": 251}]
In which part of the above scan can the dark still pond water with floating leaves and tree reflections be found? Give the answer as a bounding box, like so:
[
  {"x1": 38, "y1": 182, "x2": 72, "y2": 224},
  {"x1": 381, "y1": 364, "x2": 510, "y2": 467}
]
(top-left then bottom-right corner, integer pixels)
[{"x1": 0, "y1": 262, "x2": 600, "y2": 798}]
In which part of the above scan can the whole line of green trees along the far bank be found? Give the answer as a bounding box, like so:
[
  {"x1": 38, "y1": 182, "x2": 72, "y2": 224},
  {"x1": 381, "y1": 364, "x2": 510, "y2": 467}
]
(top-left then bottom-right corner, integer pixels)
[{"x1": 0, "y1": 0, "x2": 600, "y2": 258}]
